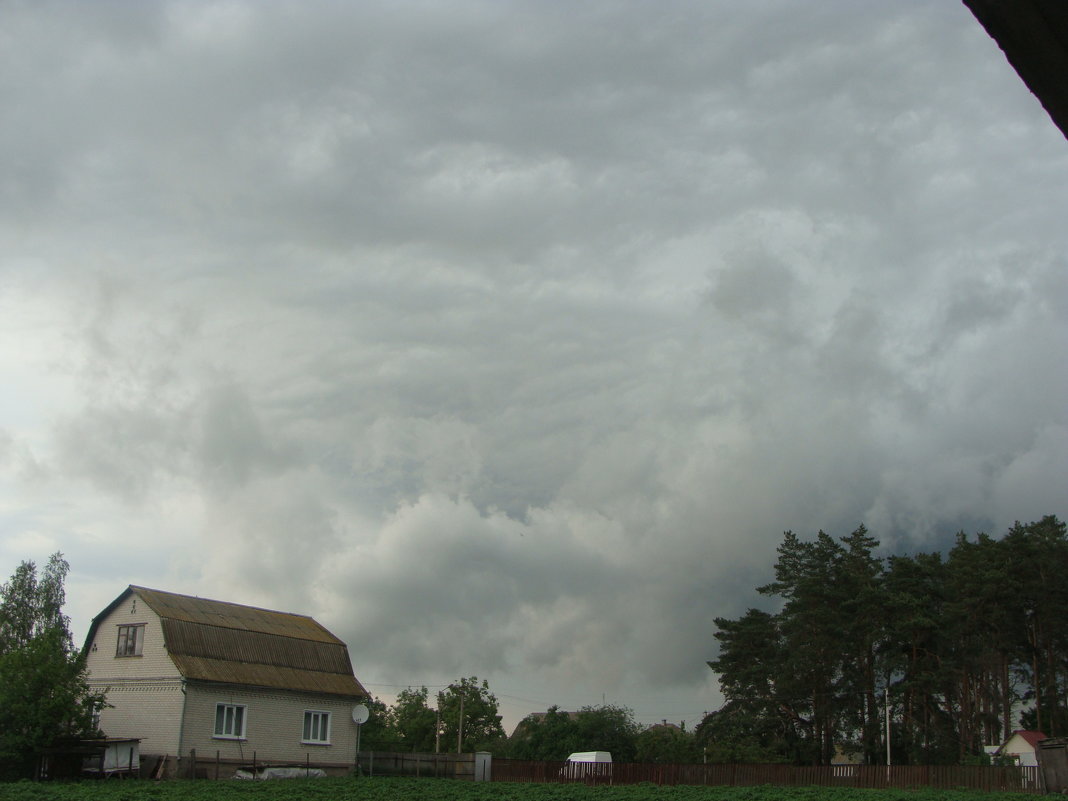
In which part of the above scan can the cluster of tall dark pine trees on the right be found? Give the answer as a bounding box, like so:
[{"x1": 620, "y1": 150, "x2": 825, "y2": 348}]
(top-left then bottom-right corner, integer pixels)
[{"x1": 700, "y1": 516, "x2": 1068, "y2": 765}]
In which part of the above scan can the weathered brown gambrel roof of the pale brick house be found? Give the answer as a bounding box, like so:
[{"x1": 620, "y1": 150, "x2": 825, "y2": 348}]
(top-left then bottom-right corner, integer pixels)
[{"x1": 85, "y1": 584, "x2": 367, "y2": 697}]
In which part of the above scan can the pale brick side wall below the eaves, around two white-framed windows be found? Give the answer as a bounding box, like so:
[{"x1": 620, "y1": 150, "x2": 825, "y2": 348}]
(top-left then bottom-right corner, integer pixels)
[{"x1": 182, "y1": 681, "x2": 358, "y2": 766}]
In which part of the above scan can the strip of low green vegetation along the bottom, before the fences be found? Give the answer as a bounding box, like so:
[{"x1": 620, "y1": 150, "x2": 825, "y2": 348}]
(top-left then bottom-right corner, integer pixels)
[{"x1": 0, "y1": 778, "x2": 1035, "y2": 801}]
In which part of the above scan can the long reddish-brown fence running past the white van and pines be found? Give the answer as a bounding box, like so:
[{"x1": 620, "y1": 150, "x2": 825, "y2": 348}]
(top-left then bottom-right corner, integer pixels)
[{"x1": 492, "y1": 759, "x2": 1042, "y2": 792}]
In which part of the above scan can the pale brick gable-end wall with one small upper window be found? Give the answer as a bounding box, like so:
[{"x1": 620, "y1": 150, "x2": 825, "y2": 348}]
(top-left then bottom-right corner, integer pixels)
[{"x1": 85, "y1": 593, "x2": 185, "y2": 756}]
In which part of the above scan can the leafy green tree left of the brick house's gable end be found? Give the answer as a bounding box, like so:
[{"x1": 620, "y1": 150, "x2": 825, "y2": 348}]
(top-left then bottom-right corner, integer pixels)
[{"x1": 0, "y1": 553, "x2": 104, "y2": 780}]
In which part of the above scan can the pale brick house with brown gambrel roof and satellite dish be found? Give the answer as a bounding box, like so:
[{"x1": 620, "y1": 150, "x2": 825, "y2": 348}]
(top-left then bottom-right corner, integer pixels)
[{"x1": 84, "y1": 585, "x2": 367, "y2": 775}]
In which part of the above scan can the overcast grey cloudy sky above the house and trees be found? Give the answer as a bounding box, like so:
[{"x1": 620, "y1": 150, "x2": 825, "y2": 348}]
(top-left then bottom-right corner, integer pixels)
[{"x1": 0, "y1": 0, "x2": 1068, "y2": 728}]
